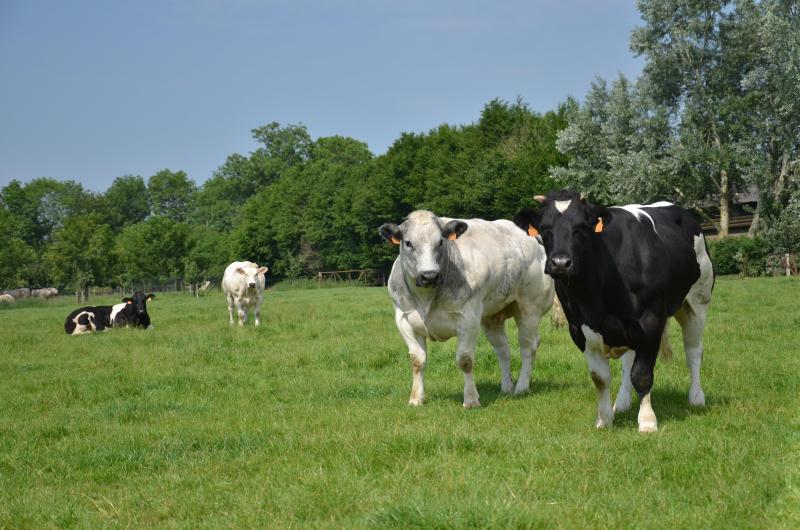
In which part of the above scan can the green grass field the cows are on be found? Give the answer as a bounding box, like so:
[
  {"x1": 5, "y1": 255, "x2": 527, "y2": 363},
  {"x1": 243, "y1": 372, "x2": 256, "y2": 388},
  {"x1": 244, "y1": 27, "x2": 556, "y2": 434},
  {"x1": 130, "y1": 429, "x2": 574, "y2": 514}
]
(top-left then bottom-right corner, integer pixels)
[{"x1": 0, "y1": 278, "x2": 800, "y2": 529}]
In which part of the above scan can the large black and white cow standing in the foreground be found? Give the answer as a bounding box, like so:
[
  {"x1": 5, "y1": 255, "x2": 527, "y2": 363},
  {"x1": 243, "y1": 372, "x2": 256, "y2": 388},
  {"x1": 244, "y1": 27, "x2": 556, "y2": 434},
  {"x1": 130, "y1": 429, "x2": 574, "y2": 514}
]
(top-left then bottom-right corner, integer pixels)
[{"x1": 515, "y1": 191, "x2": 714, "y2": 432}]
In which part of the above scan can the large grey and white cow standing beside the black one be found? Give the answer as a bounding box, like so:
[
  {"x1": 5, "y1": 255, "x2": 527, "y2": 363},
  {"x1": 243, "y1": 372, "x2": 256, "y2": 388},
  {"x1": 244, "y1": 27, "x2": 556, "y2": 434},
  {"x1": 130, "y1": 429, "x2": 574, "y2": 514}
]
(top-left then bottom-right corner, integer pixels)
[{"x1": 380, "y1": 210, "x2": 554, "y2": 408}]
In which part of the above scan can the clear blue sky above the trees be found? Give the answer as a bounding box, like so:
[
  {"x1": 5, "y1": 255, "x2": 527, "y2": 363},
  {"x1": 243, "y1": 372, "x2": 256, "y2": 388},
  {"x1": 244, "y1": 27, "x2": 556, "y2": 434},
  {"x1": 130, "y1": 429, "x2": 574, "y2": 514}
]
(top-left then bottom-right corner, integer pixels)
[{"x1": 0, "y1": 0, "x2": 643, "y2": 191}]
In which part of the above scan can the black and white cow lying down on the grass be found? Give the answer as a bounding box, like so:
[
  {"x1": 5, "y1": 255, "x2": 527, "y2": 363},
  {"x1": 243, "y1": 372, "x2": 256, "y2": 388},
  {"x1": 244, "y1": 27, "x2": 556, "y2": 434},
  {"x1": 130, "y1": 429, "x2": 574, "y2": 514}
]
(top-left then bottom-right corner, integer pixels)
[{"x1": 64, "y1": 291, "x2": 155, "y2": 335}]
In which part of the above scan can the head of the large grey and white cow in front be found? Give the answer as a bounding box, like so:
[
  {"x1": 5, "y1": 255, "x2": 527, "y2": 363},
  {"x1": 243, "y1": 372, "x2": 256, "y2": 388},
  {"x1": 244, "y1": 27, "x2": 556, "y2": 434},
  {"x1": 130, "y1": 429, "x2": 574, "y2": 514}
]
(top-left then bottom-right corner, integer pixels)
[{"x1": 379, "y1": 210, "x2": 467, "y2": 287}]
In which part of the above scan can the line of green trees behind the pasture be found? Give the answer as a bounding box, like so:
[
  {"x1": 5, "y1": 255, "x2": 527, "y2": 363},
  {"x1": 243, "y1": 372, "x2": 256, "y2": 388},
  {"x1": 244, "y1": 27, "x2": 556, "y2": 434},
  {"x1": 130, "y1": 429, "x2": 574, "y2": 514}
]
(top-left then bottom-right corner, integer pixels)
[{"x1": 0, "y1": 0, "x2": 800, "y2": 291}]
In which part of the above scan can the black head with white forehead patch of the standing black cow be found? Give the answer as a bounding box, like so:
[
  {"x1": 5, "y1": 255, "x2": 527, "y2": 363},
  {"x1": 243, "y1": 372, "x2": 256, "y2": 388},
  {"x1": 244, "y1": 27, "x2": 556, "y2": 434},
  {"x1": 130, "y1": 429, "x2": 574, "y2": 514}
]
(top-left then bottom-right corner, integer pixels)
[{"x1": 514, "y1": 190, "x2": 607, "y2": 278}]
